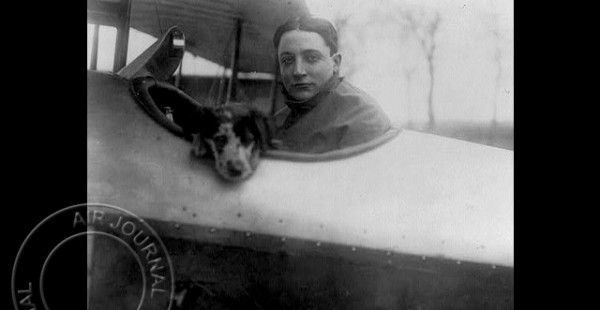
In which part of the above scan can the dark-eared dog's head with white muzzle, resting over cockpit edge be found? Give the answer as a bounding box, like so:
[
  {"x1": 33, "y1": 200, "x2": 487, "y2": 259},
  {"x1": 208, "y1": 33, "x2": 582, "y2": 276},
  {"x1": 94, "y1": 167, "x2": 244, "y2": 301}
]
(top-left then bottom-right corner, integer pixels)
[{"x1": 181, "y1": 103, "x2": 271, "y2": 181}]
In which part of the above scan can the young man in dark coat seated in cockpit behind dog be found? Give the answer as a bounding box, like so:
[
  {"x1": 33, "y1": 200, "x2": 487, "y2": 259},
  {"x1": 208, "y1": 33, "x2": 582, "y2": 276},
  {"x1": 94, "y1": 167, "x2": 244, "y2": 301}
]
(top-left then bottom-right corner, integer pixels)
[{"x1": 273, "y1": 16, "x2": 391, "y2": 153}]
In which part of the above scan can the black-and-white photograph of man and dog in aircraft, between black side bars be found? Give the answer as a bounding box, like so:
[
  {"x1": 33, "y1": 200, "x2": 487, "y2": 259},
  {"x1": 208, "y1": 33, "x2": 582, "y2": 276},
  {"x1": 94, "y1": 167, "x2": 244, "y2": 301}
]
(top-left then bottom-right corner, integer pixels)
[{"x1": 82, "y1": 0, "x2": 514, "y2": 310}]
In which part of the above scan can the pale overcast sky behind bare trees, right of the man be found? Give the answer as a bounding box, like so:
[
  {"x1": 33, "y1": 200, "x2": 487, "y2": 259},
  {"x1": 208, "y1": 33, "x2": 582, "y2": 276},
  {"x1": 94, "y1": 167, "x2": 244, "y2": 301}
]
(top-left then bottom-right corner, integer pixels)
[{"x1": 306, "y1": 0, "x2": 514, "y2": 122}]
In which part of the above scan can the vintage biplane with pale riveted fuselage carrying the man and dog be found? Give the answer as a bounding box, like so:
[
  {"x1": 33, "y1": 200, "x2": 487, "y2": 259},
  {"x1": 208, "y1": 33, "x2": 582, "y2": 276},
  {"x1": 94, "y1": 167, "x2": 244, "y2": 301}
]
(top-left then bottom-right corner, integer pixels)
[{"x1": 87, "y1": 0, "x2": 514, "y2": 309}]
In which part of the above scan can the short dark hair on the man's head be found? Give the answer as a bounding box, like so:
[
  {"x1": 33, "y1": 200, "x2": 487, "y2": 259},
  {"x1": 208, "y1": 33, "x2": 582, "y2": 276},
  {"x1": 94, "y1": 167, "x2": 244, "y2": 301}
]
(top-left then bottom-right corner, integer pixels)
[{"x1": 273, "y1": 15, "x2": 337, "y2": 55}]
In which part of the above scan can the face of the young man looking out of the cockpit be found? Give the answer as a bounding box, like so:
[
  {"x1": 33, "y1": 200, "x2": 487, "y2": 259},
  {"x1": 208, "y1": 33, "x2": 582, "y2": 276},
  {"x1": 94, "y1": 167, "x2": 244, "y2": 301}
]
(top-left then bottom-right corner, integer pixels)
[{"x1": 277, "y1": 30, "x2": 341, "y2": 100}]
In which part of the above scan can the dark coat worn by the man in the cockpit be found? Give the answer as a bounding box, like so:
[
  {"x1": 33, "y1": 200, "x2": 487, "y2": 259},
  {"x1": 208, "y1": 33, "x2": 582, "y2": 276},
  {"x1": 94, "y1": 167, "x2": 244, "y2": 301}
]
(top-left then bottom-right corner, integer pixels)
[{"x1": 275, "y1": 76, "x2": 391, "y2": 153}]
